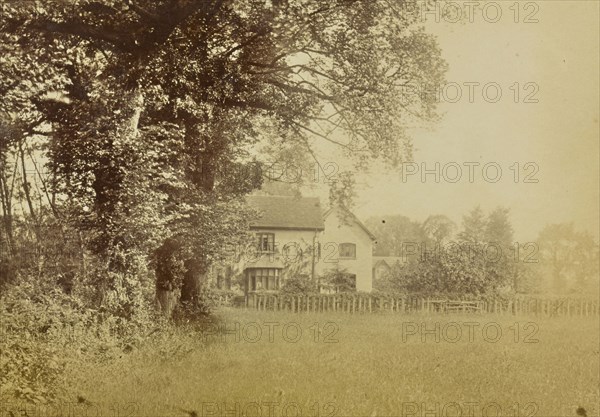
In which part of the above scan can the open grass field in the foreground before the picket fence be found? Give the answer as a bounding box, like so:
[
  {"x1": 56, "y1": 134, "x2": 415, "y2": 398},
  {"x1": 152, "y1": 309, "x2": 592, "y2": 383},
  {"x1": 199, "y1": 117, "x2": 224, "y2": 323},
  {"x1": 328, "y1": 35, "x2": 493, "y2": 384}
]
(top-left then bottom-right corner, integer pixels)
[{"x1": 45, "y1": 309, "x2": 600, "y2": 417}]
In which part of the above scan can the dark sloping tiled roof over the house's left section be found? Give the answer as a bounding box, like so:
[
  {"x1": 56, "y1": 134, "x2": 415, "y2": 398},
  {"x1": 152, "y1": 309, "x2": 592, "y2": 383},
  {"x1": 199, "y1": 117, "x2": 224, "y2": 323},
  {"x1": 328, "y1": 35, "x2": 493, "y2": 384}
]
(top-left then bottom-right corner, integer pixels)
[{"x1": 247, "y1": 195, "x2": 325, "y2": 230}]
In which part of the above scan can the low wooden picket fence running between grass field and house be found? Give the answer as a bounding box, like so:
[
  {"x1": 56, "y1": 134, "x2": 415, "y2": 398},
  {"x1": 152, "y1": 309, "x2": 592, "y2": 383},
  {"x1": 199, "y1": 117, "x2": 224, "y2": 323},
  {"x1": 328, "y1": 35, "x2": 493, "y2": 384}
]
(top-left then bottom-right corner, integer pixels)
[{"x1": 244, "y1": 294, "x2": 599, "y2": 317}]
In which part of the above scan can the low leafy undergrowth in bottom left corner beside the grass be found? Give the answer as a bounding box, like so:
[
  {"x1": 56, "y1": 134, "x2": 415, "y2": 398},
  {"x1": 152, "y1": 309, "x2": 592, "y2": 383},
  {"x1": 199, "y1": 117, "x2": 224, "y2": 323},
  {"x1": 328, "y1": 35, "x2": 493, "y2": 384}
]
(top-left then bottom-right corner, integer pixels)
[{"x1": 0, "y1": 283, "x2": 156, "y2": 403}]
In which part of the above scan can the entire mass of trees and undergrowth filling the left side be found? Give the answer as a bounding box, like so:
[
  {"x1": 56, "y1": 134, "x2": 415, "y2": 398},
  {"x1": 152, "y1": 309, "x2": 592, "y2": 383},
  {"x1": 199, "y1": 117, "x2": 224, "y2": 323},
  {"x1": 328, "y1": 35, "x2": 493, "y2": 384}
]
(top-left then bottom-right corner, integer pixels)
[{"x1": 0, "y1": 0, "x2": 446, "y2": 402}]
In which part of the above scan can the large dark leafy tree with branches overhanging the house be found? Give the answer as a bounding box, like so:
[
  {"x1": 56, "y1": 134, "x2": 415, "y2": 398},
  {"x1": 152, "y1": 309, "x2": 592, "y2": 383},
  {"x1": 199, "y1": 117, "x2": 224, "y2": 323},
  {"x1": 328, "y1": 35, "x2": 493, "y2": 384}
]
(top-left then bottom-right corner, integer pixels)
[{"x1": 0, "y1": 0, "x2": 446, "y2": 310}]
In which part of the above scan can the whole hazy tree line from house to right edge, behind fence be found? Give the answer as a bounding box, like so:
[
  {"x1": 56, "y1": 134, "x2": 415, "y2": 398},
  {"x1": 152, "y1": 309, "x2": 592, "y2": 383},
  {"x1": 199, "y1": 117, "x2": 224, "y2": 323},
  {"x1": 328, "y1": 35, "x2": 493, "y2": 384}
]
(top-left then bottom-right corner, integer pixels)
[{"x1": 366, "y1": 207, "x2": 599, "y2": 295}]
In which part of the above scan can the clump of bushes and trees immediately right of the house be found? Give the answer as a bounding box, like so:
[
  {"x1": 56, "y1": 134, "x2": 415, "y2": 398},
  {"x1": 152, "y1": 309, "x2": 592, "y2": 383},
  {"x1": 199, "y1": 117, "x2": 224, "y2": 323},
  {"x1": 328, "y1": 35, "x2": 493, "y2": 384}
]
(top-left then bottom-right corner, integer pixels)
[{"x1": 370, "y1": 207, "x2": 526, "y2": 295}]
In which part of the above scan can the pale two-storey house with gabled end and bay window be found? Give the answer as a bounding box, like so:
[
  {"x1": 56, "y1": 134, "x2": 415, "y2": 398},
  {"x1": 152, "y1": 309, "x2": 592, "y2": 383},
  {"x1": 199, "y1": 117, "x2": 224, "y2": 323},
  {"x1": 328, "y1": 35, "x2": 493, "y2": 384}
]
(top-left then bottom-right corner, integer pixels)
[{"x1": 225, "y1": 196, "x2": 375, "y2": 294}]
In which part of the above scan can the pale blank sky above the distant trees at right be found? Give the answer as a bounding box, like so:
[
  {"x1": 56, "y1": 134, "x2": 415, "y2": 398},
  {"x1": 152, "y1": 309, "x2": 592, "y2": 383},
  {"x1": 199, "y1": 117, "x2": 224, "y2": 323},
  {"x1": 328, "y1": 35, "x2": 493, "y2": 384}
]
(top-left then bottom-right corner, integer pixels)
[{"x1": 304, "y1": 0, "x2": 600, "y2": 242}]
